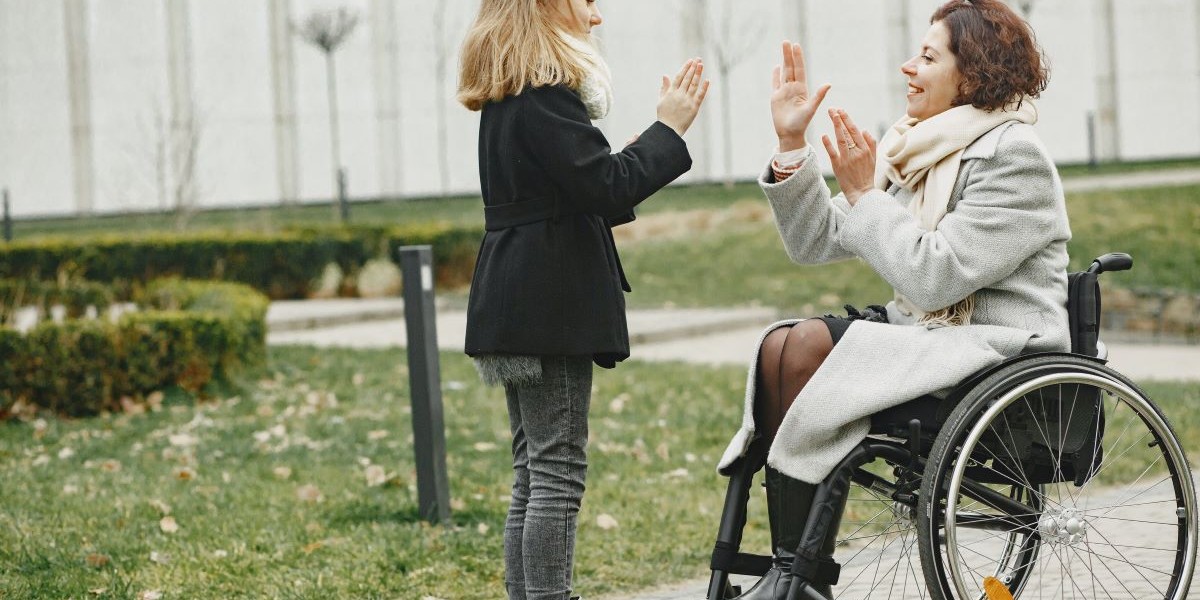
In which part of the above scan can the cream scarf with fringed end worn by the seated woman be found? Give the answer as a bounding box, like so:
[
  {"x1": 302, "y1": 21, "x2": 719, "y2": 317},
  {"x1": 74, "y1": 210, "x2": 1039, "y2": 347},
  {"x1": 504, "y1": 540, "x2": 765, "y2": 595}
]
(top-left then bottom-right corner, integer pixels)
[{"x1": 875, "y1": 97, "x2": 1038, "y2": 326}]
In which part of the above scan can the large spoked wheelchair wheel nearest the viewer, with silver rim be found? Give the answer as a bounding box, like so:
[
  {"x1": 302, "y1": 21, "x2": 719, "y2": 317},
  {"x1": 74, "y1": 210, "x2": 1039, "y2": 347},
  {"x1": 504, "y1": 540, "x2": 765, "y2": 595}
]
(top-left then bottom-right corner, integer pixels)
[{"x1": 917, "y1": 355, "x2": 1196, "y2": 600}]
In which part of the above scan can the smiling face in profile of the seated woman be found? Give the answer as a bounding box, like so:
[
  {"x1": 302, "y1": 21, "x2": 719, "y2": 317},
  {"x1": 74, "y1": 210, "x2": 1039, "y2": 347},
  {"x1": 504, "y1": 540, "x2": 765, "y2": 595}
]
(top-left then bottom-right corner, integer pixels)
[{"x1": 900, "y1": 20, "x2": 962, "y2": 121}]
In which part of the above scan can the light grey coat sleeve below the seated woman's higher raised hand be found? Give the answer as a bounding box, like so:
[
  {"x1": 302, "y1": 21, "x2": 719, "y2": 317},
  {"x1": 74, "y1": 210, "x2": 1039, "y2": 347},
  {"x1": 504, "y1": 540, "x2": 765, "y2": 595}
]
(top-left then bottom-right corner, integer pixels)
[{"x1": 758, "y1": 145, "x2": 859, "y2": 264}]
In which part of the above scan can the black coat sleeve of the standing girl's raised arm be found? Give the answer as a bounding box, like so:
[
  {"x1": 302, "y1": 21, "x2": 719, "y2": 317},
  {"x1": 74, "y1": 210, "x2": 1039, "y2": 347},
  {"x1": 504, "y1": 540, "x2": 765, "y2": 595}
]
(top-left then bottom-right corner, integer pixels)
[{"x1": 518, "y1": 86, "x2": 691, "y2": 217}]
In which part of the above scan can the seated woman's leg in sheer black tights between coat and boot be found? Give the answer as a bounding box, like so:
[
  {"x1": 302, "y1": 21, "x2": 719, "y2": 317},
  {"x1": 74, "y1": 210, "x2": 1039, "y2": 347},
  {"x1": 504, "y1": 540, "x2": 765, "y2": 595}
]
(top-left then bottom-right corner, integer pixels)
[{"x1": 755, "y1": 319, "x2": 834, "y2": 448}]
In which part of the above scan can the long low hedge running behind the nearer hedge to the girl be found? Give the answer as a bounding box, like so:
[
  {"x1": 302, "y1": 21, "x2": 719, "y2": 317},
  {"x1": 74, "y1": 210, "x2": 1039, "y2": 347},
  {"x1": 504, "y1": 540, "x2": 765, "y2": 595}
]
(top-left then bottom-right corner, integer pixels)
[{"x1": 0, "y1": 223, "x2": 484, "y2": 299}]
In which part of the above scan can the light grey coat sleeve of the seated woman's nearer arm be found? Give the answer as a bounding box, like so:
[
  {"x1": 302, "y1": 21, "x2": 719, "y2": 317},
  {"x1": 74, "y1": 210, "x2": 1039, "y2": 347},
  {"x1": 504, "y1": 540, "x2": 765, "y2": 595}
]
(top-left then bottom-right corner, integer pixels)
[{"x1": 840, "y1": 140, "x2": 1070, "y2": 311}]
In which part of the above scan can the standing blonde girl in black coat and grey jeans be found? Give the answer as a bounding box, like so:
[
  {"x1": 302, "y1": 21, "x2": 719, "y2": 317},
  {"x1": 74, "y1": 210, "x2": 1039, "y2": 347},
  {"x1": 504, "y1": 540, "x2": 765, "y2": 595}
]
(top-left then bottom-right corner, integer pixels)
[{"x1": 458, "y1": 0, "x2": 708, "y2": 600}]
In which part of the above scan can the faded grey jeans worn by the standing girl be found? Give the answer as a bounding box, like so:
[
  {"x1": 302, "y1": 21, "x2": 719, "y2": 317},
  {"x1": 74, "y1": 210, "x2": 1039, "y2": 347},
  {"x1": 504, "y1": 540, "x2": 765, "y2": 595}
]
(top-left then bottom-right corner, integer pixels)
[{"x1": 504, "y1": 356, "x2": 592, "y2": 600}]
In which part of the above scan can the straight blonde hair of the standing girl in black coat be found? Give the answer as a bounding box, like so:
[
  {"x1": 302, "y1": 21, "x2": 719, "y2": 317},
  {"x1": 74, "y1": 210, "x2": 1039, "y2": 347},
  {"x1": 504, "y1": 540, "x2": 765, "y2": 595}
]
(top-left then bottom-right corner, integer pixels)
[{"x1": 457, "y1": 0, "x2": 587, "y2": 110}]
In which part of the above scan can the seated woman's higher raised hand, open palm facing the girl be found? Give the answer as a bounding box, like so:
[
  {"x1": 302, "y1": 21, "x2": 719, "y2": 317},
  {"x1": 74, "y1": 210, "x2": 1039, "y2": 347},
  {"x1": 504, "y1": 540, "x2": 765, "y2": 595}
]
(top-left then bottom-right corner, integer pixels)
[{"x1": 770, "y1": 42, "x2": 829, "y2": 152}]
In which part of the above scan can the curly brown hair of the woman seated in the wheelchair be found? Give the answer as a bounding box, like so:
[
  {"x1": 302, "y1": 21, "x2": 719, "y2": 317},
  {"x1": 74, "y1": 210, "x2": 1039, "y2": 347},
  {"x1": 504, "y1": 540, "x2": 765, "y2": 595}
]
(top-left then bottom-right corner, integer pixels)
[{"x1": 929, "y1": 0, "x2": 1050, "y2": 110}]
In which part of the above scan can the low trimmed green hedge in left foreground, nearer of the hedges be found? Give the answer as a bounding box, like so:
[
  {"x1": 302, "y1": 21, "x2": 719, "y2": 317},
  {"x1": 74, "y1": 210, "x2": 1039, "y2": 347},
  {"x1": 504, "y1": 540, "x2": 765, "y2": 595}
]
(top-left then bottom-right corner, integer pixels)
[{"x1": 0, "y1": 280, "x2": 268, "y2": 418}]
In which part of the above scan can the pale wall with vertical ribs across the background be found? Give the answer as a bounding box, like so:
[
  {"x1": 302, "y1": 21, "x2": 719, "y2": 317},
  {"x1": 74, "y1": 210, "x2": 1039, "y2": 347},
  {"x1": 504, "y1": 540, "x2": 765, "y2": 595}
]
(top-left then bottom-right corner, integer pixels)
[{"x1": 0, "y1": 0, "x2": 1200, "y2": 216}]
